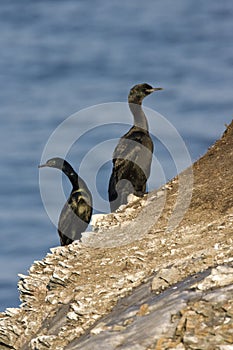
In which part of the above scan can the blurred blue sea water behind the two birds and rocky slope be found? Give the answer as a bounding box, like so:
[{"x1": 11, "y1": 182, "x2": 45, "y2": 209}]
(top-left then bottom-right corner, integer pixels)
[{"x1": 0, "y1": 0, "x2": 233, "y2": 310}]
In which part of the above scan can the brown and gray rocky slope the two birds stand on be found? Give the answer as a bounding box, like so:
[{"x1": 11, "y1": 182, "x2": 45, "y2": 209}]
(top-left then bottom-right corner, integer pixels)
[{"x1": 0, "y1": 123, "x2": 233, "y2": 350}]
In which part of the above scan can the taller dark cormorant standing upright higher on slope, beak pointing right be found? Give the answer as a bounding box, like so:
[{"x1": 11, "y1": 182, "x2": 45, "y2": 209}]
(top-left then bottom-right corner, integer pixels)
[{"x1": 108, "y1": 84, "x2": 162, "y2": 211}]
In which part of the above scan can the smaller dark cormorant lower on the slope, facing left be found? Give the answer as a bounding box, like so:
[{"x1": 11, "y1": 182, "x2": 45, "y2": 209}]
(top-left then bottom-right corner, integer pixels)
[{"x1": 39, "y1": 158, "x2": 92, "y2": 246}]
